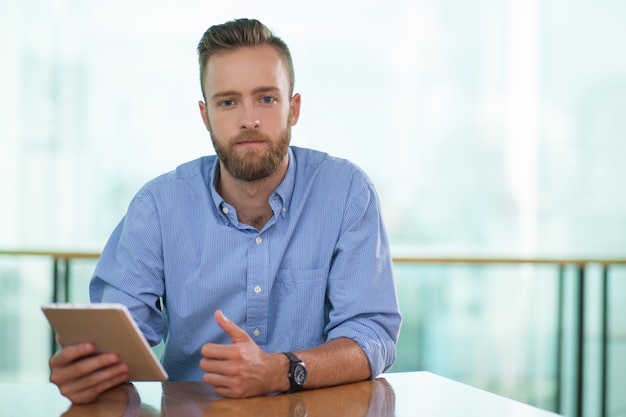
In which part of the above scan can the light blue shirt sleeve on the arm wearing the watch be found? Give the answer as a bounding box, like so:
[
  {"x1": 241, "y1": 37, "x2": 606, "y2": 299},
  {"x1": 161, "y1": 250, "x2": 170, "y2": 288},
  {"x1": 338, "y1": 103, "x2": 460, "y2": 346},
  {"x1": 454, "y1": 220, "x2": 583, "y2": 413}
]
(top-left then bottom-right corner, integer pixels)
[{"x1": 327, "y1": 171, "x2": 402, "y2": 377}]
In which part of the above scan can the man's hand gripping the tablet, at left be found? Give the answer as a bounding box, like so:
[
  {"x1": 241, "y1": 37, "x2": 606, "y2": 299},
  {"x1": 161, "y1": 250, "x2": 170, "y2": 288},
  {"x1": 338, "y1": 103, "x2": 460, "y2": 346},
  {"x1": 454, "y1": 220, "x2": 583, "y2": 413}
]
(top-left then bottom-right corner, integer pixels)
[{"x1": 50, "y1": 343, "x2": 128, "y2": 404}]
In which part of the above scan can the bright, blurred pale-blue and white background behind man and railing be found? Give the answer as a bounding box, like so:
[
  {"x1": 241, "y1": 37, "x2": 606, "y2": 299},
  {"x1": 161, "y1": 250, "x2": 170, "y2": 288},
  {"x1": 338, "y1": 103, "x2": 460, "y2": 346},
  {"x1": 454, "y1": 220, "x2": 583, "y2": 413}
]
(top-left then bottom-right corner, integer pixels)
[{"x1": 0, "y1": 0, "x2": 626, "y2": 416}]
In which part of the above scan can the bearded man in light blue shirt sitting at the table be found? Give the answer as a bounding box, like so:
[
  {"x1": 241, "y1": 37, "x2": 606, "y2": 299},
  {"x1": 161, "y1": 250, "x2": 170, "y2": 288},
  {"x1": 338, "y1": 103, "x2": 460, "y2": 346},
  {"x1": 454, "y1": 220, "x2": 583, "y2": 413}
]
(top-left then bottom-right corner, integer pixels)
[{"x1": 50, "y1": 19, "x2": 401, "y2": 403}]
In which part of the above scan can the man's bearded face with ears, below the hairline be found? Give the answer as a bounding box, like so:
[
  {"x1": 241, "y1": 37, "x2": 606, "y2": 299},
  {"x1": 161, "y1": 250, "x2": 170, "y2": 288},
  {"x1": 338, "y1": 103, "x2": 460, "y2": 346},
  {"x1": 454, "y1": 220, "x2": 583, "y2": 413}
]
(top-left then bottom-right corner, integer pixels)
[{"x1": 200, "y1": 45, "x2": 300, "y2": 181}]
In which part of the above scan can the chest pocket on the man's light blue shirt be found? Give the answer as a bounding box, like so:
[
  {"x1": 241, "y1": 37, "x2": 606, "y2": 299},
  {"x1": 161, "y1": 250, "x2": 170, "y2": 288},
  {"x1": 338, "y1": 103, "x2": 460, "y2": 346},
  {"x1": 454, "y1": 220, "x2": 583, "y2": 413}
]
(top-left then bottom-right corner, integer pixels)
[{"x1": 270, "y1": 268, "x2": 328, "y2": 350}]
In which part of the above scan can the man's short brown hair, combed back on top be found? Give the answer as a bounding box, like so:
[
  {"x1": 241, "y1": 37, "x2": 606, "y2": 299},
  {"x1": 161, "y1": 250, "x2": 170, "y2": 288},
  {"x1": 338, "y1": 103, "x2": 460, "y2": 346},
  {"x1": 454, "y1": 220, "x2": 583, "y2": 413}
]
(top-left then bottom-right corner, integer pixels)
[{"x1": 198, "y1": 19, "x2": 295, "y2": 100}]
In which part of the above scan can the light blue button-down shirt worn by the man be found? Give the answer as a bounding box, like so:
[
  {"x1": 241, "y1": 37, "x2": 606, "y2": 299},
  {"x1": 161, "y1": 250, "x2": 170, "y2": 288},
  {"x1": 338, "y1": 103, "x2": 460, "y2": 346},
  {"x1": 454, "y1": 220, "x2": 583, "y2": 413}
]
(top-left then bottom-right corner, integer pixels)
[{"x1": 90, "y1": 147, "x2": 401, "y2": 381}]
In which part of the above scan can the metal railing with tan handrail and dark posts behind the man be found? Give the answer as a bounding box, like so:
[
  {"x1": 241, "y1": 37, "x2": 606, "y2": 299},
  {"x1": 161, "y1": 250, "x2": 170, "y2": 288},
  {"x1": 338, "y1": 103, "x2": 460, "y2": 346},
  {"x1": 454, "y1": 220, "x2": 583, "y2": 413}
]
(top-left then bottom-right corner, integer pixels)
[{"x1": 0, "y1": 250, "x2": 626, "y2": 417}]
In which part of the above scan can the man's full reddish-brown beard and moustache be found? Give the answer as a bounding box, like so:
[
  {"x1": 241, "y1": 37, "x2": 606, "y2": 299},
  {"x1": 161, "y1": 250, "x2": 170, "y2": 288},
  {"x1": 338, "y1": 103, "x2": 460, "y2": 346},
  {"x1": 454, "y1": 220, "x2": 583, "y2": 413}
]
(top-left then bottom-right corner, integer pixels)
[{"x1": 210, "y1": 118, "x2": 291, "y2": 182}]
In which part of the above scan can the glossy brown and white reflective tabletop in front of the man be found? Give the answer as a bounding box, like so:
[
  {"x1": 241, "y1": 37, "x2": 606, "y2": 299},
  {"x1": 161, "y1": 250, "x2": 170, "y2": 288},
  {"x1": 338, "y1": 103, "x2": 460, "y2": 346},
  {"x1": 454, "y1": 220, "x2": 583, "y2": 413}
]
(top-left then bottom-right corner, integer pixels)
[{"x1": 0, "y1": 372, "x2": 556, "y2": 417}]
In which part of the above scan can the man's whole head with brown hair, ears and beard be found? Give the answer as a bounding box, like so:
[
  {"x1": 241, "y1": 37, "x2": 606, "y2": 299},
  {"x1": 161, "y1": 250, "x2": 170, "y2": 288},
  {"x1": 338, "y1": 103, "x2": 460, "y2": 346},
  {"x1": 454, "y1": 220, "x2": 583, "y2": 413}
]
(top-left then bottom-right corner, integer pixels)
[{"x1": 198, "y1": 20, "x2": 300, "y2": 182}]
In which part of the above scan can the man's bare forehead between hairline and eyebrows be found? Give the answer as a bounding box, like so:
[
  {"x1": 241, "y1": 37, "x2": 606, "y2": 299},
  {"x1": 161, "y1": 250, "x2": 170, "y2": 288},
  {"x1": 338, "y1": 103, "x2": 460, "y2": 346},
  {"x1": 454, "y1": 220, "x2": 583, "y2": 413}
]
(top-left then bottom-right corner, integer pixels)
[{"x1": 204, "y1": 45, "x2": 289, "y2": 98}]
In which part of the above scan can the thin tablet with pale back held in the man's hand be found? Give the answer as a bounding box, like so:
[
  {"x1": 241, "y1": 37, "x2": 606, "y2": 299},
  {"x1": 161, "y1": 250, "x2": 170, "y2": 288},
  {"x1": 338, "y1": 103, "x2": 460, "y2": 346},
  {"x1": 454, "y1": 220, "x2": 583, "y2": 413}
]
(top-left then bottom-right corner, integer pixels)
[{"x1": 41, "y1": 303, "x2": 167, "y2": 381}]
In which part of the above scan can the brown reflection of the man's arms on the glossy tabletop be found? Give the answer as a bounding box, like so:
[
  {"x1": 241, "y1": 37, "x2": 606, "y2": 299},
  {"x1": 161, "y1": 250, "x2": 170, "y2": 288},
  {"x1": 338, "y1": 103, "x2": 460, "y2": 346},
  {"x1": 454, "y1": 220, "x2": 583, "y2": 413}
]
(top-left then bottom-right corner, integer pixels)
[{"x1": 58, "y1": 378, "x2": 394, "y2": 417}]
